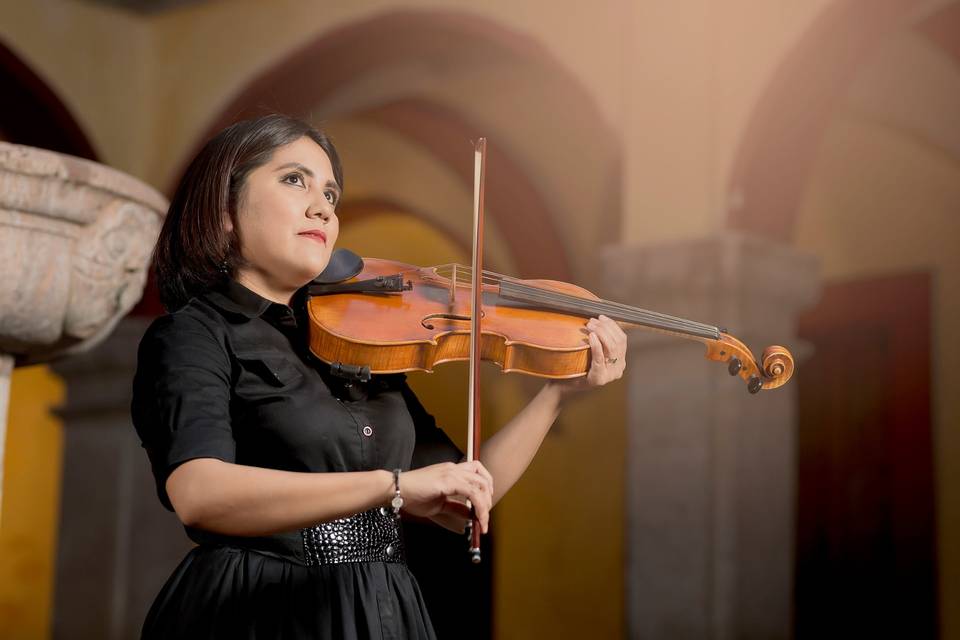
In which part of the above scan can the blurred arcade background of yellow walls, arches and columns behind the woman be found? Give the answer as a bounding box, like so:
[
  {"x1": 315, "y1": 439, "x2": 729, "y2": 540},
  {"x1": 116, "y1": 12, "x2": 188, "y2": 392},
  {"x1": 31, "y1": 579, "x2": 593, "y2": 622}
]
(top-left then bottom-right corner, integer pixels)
[{"x1": 0, "y1": 0, "x2": 960, "y2": 639}]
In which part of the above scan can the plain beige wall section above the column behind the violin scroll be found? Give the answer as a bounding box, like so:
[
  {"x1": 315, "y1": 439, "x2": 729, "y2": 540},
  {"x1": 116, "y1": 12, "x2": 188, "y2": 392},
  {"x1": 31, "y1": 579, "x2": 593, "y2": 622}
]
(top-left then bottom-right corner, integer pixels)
[{"x1": 621, "y1": 0, "x2": 830, "y2": 243}]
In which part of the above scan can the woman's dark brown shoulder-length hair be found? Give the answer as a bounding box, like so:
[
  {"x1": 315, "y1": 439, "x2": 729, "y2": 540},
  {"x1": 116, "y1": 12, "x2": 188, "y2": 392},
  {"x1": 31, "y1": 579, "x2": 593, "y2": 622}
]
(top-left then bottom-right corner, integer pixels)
[{"x1": 153, "y1": 114, "x2": 343, "y2": 312}]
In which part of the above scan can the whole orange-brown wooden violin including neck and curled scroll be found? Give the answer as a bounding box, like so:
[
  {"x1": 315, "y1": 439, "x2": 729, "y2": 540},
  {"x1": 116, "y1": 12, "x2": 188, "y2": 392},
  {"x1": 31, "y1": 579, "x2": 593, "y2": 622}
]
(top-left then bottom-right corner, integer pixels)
[{"x1": 307, "y1": 258, "x2": 793, "y2": 393}]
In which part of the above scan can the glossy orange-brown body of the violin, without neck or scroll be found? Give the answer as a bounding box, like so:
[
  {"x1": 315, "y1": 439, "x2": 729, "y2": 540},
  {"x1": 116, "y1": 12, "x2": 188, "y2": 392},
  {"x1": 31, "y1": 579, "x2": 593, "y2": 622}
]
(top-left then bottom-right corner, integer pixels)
[{"x1": 307, "y1": 258, "x2": 591, "y2": 378}]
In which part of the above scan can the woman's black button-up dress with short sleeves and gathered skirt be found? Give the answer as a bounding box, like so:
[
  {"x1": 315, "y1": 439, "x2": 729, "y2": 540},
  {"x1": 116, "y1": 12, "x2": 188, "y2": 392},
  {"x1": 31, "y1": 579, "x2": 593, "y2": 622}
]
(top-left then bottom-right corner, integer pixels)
[{"x1": 131, "y1": 281, "x2": 461, "y2": 640}]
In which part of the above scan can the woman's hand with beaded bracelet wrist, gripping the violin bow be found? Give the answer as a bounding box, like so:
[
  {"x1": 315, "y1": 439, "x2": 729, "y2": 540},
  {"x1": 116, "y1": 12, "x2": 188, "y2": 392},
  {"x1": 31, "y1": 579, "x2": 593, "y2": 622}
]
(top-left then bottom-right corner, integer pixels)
[{"x1": 400, "y1": 460, "x2": 493, "y2": 533}]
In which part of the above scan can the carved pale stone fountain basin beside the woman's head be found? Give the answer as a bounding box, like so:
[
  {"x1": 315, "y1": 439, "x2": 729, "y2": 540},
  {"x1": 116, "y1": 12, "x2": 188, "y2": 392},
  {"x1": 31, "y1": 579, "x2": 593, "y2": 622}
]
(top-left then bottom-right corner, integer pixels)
[{"x1": 0, "y1": 142, "x2": 168, "y2": 365}]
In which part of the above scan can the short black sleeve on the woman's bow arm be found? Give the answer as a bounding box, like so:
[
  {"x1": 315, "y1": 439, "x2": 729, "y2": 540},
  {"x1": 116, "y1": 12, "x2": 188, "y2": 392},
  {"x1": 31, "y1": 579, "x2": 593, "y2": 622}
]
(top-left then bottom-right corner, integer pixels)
[{"x1": 131, "y1": 314, "x2": 236, "y2": 511}]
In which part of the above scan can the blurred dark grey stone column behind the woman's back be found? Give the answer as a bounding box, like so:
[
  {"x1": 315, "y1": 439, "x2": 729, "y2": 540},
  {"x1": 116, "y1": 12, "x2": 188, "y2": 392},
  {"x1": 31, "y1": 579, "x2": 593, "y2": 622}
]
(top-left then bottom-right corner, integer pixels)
[{"x1": 53, "y1": 318, "x2": 192, "y2": 640}]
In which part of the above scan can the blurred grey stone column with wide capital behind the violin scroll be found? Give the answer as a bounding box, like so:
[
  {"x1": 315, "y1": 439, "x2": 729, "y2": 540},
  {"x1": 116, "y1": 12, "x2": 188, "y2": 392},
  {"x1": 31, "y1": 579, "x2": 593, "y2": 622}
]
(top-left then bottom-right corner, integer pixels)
[{"x1": 603, "y1": 233, "x2": 818, "y2": 640}]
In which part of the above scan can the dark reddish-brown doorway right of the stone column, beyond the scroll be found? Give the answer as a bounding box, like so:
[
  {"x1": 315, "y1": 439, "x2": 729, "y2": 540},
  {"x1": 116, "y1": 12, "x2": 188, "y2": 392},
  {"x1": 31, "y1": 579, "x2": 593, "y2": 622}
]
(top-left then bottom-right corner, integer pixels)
[{"x1": 795, "y1": 273, "x2": 937, "y2": 640}]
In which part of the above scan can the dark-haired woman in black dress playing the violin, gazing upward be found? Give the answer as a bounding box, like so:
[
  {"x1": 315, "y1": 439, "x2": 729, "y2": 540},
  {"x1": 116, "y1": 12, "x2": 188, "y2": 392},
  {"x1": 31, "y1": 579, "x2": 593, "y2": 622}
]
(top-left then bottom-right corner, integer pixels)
[{"x1": 132, "y1": 115, "x2": 626, "y2": 639}]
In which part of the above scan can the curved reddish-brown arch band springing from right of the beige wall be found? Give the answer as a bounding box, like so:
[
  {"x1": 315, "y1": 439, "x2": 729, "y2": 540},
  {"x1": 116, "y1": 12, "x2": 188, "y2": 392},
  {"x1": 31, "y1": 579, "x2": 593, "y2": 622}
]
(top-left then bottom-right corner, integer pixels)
[{"x1": 728, "y1": 0, "x2": 917, "y2": 243}]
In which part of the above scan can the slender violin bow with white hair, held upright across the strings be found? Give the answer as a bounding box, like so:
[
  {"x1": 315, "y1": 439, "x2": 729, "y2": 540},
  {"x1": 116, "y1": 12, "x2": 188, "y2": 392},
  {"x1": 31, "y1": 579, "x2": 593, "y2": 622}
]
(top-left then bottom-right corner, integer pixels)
[{"x1": 467, "y1": 138, "x2": 487, "y2": 564}]
